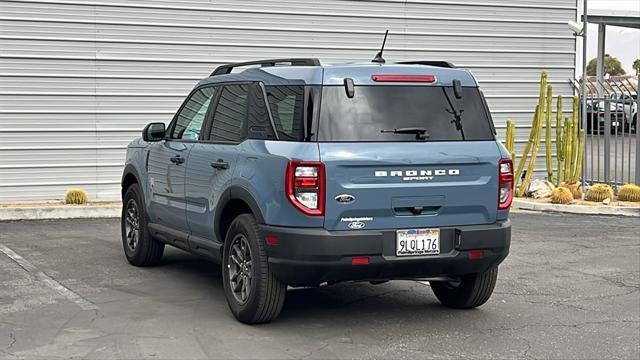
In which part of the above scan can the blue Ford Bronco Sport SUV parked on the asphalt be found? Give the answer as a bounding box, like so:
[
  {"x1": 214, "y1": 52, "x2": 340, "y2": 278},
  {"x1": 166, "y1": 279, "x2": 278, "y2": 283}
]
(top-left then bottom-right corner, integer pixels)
[{"x1": 122, "y1": 59, "x2": 514, "y2": 323}]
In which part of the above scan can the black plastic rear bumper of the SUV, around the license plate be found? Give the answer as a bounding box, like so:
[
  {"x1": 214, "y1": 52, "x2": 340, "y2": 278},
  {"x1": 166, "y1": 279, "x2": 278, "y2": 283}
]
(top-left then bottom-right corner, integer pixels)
[{"x1": 261, "y1": 220, "x2": 511, "y2": 286}]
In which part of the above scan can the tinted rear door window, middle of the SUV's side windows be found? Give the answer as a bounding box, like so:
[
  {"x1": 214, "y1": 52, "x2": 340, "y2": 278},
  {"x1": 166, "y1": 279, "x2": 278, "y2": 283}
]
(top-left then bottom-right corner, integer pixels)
[{"x1": 209, "y1": 85, "x2": 249, "y2": 143}]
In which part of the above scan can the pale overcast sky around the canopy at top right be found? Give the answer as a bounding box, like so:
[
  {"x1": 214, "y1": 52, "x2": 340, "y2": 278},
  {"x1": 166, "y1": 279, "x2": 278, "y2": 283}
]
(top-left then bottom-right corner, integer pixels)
[{"x1": 578, "y1": 0, "x2": 640, "y2": 74}]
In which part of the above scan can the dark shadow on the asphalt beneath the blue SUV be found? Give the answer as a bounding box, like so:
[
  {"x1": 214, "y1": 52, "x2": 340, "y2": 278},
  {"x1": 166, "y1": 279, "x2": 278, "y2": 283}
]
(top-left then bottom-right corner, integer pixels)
[{"x1": 152, "y1": 250, "x2": 483, "y2": 326}]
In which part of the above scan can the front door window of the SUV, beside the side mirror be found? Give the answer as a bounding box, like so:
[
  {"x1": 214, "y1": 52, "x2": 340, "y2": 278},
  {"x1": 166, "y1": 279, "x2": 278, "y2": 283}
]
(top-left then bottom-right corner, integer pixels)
[{"x1": 171, "y1": 87, "x2": 215, "y2": 140}]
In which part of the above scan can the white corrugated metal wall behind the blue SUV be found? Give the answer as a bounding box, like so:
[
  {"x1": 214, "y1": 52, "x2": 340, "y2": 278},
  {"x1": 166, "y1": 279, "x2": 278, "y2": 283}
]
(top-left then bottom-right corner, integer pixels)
[{"x1": 0, "y1": 0, "x2": 576, "y2": 201}]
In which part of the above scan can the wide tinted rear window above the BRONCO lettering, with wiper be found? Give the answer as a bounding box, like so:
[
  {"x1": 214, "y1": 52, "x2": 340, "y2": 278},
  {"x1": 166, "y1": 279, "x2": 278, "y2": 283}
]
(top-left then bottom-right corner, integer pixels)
[{"x1": 318, "y1": 85, "x2": 494, "y2": 142}]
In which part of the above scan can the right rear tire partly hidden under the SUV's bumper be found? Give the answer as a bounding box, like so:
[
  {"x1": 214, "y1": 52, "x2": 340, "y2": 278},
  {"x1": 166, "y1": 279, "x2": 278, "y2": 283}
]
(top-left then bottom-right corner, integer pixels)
[{"x1": 431, "y1": 266, "x2": 498, "y2": 309}]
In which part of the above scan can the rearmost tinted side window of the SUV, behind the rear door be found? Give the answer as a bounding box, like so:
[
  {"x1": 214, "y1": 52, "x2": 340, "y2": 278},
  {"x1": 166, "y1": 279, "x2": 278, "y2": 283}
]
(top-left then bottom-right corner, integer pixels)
[{"x1": 266, "y1": 85, "x2": 304, "y2": 141}]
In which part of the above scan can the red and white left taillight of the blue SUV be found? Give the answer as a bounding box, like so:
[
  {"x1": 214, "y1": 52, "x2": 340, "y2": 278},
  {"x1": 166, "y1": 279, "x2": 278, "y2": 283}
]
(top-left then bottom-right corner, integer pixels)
[{"x1": 285, "y1": 161, "x2": 325, "y2": 216}]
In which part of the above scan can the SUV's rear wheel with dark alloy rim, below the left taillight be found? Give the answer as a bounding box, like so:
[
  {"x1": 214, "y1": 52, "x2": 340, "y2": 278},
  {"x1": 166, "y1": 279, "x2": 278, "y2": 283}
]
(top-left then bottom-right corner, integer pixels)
[{"x1": 222, "y1": 214, "x2": 287, "y2": 324}]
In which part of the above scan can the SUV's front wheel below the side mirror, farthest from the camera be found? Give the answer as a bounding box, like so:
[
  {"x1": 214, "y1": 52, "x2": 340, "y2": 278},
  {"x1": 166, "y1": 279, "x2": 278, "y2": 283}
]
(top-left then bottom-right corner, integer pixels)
[{"x1": 120, "y1": 184, "x2": 164, "y2": 266}]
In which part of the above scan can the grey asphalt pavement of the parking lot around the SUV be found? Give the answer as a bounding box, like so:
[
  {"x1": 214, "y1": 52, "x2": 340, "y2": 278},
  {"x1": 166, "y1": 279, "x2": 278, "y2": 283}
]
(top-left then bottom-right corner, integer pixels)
[{"x1": 0, "y1": 213, "x2": 640, "y2": 359}]
